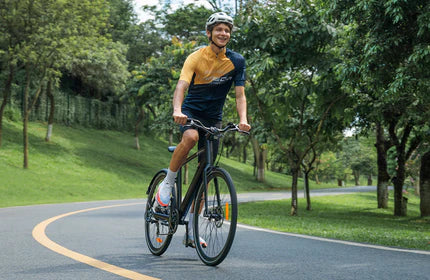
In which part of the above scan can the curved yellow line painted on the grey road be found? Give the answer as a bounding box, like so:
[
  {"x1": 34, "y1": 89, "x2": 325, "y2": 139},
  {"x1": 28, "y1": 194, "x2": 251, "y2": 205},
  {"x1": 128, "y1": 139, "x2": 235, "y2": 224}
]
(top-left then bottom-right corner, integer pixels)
[{"x1": 33, "y1": 203, "x2": 159, "y2": 280}]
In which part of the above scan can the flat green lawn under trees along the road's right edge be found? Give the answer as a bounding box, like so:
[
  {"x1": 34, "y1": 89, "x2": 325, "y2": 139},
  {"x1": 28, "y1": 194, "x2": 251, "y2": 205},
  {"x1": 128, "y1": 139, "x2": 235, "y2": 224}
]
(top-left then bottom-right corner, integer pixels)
[{"x1": 238, "y1": 193, "x2": 430, "y2": 250}]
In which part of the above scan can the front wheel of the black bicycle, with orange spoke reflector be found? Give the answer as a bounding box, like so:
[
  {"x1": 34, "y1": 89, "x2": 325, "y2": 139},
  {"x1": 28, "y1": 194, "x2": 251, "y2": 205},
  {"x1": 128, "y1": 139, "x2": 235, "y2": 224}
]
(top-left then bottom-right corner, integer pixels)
[{"x1": 194, "y1": 168, "x2": 237, "y2": 266}]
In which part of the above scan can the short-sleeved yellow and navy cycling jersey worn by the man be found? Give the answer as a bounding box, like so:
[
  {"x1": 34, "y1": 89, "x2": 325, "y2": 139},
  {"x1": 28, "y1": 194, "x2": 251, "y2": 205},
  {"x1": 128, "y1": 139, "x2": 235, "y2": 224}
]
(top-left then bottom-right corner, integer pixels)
[{"x1": 179, "y1": 46, "x2": 245, "y2": 120}]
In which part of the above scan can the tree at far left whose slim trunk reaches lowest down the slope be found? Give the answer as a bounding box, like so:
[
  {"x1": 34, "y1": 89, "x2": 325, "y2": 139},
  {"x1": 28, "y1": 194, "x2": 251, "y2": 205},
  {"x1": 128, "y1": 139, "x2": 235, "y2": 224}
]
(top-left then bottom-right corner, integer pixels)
[{"x1": 0, "y1": 0, "x2": 113, "y2": 168}]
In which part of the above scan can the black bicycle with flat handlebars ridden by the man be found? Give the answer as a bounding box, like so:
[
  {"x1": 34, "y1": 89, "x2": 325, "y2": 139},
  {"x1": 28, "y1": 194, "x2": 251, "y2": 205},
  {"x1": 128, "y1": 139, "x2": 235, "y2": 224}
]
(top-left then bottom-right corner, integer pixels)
[{"x1": 145, "y1": 119, "x2": 249, "y2": 266}]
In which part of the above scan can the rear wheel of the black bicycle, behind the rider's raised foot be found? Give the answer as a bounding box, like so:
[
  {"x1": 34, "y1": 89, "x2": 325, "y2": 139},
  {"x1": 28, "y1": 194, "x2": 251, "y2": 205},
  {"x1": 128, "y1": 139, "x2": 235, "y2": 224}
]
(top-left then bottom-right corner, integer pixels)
[{"x1": 145, "y1": 170, "x2": 173, "y2": 256}]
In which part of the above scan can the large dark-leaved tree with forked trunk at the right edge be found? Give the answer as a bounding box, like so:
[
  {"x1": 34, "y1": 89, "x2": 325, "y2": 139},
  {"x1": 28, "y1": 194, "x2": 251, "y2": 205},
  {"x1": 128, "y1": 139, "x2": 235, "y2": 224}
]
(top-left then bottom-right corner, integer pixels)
[{"x1": 322, "y1": 0, "x2": 430, "y2": 216}]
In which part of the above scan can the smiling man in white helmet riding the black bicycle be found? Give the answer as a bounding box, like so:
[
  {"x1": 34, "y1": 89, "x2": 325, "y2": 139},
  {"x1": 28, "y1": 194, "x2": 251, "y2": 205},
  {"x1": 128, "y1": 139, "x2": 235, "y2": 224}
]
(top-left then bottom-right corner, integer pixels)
[{"x1": 156, "y1": 12, "x2": 251, "y2": 248}]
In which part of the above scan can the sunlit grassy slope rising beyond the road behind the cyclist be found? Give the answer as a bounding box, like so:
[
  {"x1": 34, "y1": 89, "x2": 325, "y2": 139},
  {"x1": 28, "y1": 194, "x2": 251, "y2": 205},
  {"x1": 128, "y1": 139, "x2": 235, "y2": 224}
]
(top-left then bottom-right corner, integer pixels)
[{"x1": 0, "y1": 121, "x2": 314, "y2": 207}]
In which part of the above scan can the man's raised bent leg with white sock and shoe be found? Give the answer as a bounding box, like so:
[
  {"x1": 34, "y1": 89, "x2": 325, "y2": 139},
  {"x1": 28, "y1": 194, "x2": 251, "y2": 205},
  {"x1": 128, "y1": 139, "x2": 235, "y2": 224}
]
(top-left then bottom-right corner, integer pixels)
[{"x1": 156, "y1": 129, "x2": 199, "y2": 206}]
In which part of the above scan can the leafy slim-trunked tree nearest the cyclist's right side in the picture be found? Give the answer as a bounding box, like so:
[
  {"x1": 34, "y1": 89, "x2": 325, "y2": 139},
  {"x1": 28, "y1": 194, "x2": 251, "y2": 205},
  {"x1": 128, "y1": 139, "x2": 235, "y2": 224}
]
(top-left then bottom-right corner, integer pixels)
[{"x1": 232, "y1": 1, "x2": 347, "y2": 215}]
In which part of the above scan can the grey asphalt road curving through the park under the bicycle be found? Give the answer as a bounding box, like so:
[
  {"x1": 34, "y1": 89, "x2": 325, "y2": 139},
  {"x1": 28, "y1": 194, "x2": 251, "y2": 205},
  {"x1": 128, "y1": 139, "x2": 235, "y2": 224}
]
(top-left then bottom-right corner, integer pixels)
[{"x1": 0, "y1": 188, "x2": 430, "y2": 280}]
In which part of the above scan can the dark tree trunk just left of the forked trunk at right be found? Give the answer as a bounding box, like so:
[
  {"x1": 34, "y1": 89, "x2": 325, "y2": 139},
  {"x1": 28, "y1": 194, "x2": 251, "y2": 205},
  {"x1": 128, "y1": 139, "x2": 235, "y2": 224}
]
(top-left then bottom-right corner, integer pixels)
[{"x1": 375, "y1": 123, "x2": 390, "y2": 209}]
